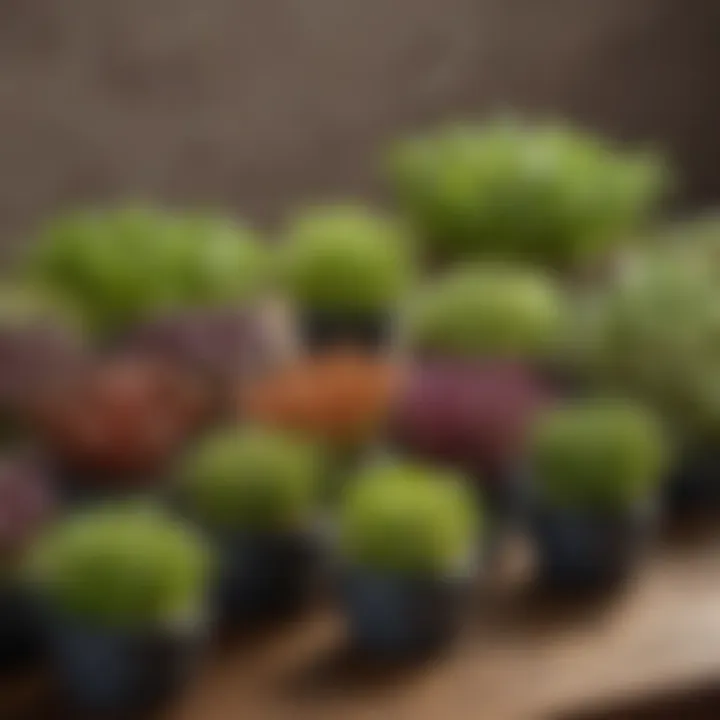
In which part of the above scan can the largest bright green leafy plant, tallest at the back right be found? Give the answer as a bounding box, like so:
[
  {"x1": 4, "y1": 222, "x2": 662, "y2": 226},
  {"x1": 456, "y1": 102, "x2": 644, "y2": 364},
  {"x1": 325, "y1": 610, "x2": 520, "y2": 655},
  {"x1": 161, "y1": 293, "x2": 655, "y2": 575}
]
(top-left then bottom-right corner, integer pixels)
[{"x1": 388, "y1": 120, "x2": 670, "y2": 270}]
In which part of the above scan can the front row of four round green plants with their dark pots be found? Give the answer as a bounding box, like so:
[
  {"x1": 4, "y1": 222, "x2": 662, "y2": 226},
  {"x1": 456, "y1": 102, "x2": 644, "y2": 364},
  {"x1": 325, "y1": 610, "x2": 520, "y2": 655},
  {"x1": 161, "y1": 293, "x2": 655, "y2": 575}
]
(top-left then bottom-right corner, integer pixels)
[{"x1": 6, "y1": 401, "x2": 663, "y2": 709}]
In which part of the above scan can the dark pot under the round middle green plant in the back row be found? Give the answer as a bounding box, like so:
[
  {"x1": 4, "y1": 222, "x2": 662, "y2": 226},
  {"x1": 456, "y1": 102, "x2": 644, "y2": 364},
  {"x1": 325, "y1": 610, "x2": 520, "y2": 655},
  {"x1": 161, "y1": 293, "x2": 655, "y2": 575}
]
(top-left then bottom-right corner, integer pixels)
[{"x1": 298, "y1": 311, "x2": 393, "y2": 353}]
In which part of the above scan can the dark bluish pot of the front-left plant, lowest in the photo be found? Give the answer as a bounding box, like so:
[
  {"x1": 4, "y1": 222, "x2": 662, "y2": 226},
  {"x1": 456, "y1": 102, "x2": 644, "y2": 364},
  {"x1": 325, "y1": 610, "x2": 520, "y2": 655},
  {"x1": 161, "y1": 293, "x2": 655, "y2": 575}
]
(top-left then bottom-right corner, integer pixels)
[{"x1": 49, "y1": 618, "x2": 204, "y2": 713}]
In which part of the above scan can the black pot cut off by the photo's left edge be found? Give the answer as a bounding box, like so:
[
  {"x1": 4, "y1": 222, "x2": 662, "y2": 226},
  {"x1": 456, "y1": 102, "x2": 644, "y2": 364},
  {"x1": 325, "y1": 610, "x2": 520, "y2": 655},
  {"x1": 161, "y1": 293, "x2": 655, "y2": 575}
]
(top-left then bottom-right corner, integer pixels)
[{"x1": 0, "y1": 584, "x2": 43, "y2": 672}]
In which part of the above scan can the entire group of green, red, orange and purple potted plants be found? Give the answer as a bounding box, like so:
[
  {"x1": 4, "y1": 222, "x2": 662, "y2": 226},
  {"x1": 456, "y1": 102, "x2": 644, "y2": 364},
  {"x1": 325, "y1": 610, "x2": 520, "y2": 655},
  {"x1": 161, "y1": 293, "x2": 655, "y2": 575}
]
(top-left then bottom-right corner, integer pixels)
[{"x1": 0, "y1": 118, "x2": 720, "y2": 707}]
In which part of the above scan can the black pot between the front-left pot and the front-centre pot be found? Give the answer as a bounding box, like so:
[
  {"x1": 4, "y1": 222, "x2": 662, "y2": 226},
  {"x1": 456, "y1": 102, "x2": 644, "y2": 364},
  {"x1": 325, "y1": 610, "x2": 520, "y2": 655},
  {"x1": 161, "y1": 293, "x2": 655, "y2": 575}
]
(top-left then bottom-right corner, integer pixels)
[{"x1": 211, "y1": 532, "x2": 320, "y2": 626}]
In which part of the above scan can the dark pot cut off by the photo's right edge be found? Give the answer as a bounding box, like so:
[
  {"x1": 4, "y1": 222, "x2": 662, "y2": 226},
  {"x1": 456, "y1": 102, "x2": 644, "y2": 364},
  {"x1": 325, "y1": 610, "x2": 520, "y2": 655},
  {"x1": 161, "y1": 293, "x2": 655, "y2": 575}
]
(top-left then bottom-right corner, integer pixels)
[{"x1": 666, "y1": 447, "x2": 720, "y2": 515}]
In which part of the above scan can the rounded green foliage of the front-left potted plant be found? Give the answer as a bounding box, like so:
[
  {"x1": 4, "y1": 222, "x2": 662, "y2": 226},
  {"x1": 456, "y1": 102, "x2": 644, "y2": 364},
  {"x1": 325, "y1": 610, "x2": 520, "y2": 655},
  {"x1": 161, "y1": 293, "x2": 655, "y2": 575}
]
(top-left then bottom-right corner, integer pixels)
[{"x1": 29, "y1": 505, "x2": 213, "y2": 630}]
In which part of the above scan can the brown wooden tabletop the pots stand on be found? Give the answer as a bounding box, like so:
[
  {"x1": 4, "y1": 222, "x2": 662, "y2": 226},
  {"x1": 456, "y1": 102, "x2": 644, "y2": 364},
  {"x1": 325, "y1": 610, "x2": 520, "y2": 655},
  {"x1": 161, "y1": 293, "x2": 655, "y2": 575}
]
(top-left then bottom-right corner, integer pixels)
[{"x1": 0, "y1": 520, "x2": 720, "y2": 720}]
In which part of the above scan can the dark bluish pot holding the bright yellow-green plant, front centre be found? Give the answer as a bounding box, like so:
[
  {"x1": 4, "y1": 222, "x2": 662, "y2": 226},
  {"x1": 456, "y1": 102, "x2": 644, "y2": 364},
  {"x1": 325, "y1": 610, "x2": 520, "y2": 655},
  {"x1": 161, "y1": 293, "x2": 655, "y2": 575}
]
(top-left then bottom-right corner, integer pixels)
[{"x1": 340, "y1": 569, "x2": 471, "y2": 658}]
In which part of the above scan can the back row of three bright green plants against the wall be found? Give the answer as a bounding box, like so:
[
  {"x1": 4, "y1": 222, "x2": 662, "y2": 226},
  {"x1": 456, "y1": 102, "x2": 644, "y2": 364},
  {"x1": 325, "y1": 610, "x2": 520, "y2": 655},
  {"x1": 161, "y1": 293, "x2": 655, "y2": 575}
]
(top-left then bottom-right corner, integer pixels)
[{"x1": 14, "y1": 122, "x2": 668, "y2": 360}]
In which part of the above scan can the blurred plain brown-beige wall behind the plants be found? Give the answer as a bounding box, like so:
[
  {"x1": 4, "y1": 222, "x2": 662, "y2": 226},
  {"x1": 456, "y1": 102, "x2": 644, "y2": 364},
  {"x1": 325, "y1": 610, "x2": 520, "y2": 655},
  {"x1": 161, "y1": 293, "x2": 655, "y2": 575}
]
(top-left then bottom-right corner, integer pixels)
[{"x1": 0, "y1": 0, "x2": 720, "y2": 253}]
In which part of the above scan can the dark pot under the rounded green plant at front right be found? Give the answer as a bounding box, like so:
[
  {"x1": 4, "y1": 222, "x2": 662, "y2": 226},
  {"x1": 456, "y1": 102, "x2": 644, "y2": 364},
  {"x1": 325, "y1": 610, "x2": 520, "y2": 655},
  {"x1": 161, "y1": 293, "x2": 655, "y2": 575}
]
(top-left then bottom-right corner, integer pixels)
[{"x1": 529, "y1": 503, "x2": 655, "y2": 590}]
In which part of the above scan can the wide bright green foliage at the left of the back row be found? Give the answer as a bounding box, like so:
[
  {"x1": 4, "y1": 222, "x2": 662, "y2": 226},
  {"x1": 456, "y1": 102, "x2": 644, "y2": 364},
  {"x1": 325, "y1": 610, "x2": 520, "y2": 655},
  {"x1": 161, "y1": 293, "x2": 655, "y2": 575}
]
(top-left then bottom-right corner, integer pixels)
[{"x1": 28, "y1": 206, "x2": 267, "y2": 334}]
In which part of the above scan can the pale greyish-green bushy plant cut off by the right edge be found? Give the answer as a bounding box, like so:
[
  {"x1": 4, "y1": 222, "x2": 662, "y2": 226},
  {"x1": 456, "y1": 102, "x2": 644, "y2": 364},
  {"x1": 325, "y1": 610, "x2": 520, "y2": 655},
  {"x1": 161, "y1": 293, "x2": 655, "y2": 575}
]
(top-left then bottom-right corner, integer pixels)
[{"x1": 567, "y1": 256, "x2": 720, "y2": 442}]
